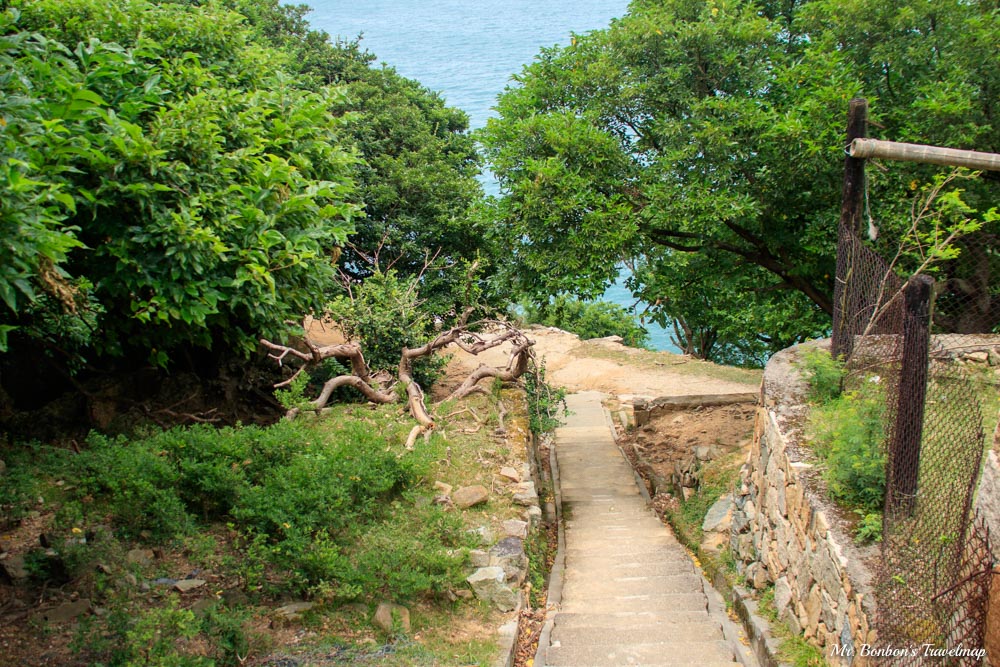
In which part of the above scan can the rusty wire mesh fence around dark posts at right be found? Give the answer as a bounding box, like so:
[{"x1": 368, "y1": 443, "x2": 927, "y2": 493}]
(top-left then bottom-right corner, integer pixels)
[{"x1": 833, "y1": 219, "x2": 1000, "y2": 665}]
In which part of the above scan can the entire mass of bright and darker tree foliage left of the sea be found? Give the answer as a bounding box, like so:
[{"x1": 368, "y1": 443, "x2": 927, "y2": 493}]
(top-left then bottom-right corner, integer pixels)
[{"x1": 0, "y1": 0, "x2": 489, "y2": 402}]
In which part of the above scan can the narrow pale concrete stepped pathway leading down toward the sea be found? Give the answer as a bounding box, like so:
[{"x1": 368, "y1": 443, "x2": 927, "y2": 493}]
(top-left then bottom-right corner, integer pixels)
[{"x1": 543, "y1": 392, "x2": 739, "y2": 667}]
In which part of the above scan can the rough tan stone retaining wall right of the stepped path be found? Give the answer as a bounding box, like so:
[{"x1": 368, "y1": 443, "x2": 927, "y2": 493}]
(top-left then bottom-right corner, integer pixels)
[{"x1": 730, "y1": 347, "x2": 875, "y2": 665}]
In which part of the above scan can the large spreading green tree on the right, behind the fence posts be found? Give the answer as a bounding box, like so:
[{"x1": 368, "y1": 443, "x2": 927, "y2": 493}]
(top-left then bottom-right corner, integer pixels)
[{"x1": 482, "y1": 0, "x2": 1000, "y2": 361}]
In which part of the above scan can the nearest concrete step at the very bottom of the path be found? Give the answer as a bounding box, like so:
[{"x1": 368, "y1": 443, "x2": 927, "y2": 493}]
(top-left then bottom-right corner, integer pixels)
[{"x1": 545, "y1": 641, "x2": 735, "y2": 667}]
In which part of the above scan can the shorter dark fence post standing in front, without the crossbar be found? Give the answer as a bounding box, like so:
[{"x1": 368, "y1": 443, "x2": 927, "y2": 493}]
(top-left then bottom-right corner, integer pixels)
[{"x1": 886, "y1": 275, "x2": 934, "y2": 514}]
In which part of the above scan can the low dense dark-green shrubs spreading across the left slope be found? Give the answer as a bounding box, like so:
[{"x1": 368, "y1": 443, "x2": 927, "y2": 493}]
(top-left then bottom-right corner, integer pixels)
[{"x1": 0, "y1": 419, "x2": 466, "y2": 601}]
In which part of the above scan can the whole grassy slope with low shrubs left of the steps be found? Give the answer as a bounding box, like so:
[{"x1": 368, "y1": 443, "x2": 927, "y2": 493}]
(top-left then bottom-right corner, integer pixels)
[{"x1": 0, "y1": 396, "x2": 544, "y2": 665}]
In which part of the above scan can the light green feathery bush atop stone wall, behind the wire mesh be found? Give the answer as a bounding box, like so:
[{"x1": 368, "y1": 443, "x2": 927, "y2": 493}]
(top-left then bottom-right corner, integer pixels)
[{"x1": 809, "y1": 376, "x2": 886, "y2": 513}]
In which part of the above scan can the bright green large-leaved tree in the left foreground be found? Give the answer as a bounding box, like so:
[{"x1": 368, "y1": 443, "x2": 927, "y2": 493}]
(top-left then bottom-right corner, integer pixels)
[{"x1": 0, "y1": 0, "x2": 359, "y2": 364}]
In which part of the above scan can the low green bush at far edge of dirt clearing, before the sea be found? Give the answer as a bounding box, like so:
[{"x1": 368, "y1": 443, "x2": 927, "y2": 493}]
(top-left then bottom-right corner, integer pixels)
[{"x1": 520, "y1": 294, "x2": 649, "y2": 347}]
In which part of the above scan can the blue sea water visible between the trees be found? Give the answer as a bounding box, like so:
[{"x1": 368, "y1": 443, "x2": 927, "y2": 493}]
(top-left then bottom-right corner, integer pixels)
[{"x1": 306, "y1": 0, "x2": 676, "y2": 351}]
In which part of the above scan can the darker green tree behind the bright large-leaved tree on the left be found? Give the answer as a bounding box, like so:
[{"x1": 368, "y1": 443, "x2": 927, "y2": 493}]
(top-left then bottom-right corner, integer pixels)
[{"x1": 226, "y1": 0, "x2": 496, "y2": 313}]
